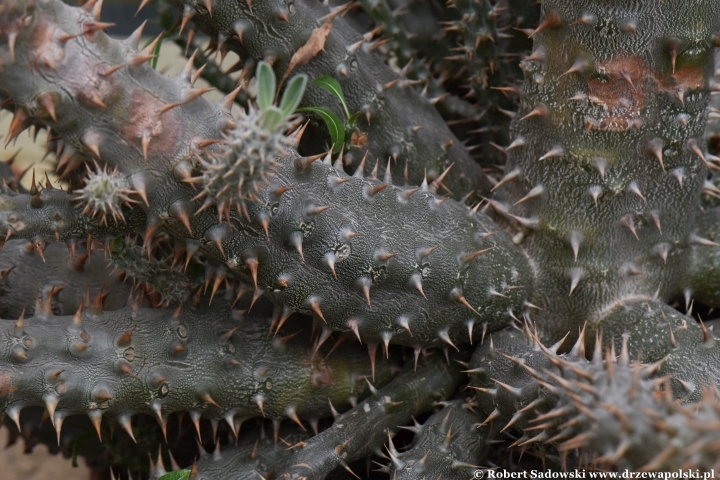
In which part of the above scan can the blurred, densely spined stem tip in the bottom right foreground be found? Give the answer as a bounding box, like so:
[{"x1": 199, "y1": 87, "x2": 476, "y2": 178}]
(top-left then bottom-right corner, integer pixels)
[{"x1": 470, "y1": 329, "x2": 720, "y2": 471}]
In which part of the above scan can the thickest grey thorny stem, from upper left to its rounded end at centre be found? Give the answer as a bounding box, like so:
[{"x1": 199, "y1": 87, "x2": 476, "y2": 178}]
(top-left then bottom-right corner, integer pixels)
[{"x1": 0, "y1": 2, "x2": 533, "y2": 348}]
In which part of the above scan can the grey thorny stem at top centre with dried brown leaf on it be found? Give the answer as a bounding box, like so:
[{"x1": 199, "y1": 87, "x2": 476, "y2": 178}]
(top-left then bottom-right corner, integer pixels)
[{"x1": 164, "y1": 0, "x2": 489, "y2": 199}]
